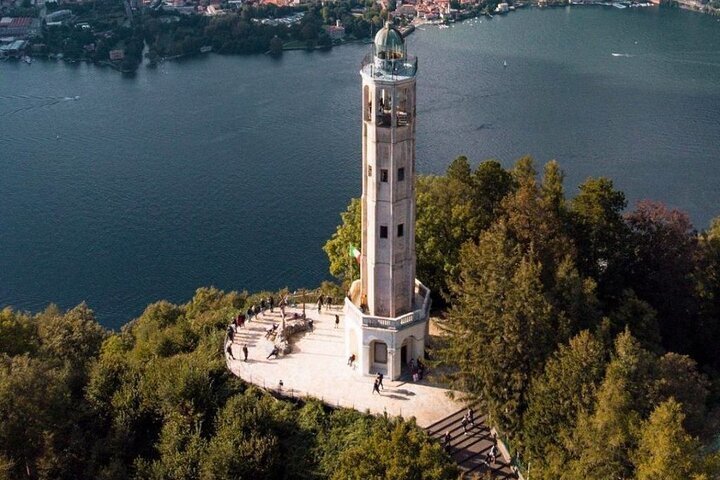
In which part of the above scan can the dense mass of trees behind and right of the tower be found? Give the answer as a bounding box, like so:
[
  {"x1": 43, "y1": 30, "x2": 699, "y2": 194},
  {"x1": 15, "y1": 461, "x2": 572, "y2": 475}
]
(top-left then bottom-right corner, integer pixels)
[{"x1": 325, "y1": 156, "x2": 720, "y2": 480}]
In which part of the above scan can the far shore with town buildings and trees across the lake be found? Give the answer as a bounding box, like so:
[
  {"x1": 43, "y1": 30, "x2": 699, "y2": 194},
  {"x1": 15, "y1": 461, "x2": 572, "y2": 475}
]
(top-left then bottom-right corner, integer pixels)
[{"x1": 0, "y1": 0, "x2": 720, "y2": 72}]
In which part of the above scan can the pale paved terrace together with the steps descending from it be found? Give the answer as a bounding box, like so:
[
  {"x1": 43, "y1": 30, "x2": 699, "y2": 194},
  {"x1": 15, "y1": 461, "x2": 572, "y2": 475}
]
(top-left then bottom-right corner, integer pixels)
[{"x1": 226, "y1": 304, "x2": 517, "y2": 479}]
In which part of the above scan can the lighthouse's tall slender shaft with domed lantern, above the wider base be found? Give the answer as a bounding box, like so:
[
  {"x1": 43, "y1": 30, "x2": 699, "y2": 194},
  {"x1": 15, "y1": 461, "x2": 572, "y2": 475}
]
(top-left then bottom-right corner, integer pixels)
[{"x1": 360, "y1": 25, "x2": 417, "y2": 317}]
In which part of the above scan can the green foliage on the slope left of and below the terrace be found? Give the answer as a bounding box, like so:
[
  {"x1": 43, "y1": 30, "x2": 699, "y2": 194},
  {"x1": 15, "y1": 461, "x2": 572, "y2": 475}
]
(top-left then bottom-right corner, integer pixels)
[{"x1": 0, "y1": 288, "x2": 455, "y2": 480}]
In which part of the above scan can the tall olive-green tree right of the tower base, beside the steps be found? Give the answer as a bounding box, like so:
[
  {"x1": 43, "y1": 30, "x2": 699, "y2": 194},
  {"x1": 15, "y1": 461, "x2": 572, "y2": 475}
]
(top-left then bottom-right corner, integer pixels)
[{"x1": 439, "y1": 222, "x2": 555, "y2": 435}]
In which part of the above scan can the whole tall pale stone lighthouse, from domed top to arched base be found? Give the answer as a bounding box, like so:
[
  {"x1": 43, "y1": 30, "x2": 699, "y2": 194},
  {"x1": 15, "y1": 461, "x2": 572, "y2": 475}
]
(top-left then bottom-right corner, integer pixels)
[{"x1": 345, "y1": 23, "x2": 430, "y2": 379}]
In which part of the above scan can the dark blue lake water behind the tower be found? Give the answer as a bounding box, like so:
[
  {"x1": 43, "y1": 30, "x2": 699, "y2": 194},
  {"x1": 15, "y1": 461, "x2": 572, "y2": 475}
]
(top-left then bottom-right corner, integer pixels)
[{"x1": 0, "y1": 7, "x2": 720, "y2": 328}]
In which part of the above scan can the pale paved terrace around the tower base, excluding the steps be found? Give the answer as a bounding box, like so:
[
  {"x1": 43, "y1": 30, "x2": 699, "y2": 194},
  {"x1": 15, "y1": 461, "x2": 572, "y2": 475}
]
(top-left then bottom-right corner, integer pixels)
[{"x1": 228, "y1": 305, "x2": 462, "y2": 427}]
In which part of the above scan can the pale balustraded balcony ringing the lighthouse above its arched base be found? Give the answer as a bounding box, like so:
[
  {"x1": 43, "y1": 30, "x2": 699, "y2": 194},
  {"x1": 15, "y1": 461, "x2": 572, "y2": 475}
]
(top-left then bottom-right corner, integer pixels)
[{"x1": 345, "y1": 279, "x2": 432, "y2": 330}]
